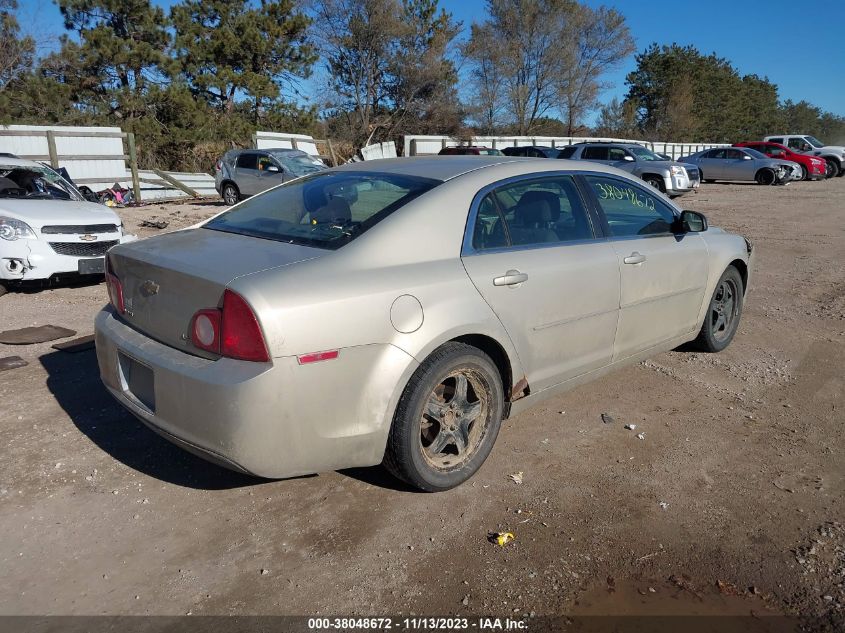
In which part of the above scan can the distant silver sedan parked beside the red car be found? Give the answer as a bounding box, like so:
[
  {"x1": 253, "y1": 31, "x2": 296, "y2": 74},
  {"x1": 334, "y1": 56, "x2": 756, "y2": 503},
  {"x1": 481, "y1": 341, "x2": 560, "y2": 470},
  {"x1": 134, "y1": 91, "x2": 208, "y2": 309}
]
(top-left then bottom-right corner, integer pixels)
[{"x1": 678, "y1": 147, "x2": 796, "y2": 185}]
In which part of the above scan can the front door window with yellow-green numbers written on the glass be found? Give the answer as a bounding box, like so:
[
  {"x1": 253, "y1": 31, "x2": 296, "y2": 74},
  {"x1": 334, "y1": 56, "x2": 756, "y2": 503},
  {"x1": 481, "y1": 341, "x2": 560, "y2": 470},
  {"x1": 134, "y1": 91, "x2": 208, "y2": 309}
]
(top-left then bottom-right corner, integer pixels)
[{"x1": 586, "y1": 176, "x2": 675, "y2": 237}]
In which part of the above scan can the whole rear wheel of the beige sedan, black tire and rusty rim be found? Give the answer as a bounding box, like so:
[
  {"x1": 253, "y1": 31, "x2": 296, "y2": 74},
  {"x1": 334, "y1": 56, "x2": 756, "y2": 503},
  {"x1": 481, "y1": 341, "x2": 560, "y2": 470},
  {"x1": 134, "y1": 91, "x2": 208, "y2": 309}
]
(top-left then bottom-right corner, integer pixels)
[{"x1": 383, "y1": 342, "x2": 504, "y2": 492}]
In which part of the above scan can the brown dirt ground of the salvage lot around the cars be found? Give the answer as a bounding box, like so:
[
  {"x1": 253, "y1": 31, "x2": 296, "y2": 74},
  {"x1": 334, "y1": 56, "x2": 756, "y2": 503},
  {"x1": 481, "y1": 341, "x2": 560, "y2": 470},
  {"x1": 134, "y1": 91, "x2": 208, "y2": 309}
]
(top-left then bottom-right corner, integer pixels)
[{"x1": 0, "y1": 178, "x2": 845, "y2": 630}]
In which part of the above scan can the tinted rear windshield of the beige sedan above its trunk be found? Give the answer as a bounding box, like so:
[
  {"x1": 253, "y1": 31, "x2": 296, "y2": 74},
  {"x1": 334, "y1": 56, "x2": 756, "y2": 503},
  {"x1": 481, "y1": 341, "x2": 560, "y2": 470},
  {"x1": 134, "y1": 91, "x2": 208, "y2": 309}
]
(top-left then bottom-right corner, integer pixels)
[{"x1": 203, "y1": 172, "x2": 440, "y2": 250}]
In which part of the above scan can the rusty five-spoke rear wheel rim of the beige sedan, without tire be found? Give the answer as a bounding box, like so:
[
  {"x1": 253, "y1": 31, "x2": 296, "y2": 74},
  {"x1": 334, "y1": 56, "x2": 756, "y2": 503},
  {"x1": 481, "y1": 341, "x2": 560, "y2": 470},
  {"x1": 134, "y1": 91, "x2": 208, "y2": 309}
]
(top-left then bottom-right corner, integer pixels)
[{"x1": 420, "y1": 367, "x2": 489, "y2": 470}]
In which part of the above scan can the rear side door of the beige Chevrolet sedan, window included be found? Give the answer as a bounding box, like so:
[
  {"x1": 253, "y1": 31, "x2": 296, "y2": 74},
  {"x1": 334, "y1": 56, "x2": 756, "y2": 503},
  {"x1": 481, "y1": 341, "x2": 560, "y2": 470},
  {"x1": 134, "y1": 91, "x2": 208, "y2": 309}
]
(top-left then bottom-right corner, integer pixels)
[{"x1": 462, "y1": 175, "x2": 619, "y2": 392}]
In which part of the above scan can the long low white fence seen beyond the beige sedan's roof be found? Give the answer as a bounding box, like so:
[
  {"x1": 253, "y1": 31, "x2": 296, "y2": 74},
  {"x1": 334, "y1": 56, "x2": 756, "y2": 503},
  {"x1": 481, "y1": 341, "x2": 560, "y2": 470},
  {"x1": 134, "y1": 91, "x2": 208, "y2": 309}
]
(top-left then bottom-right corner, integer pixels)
[{"x1": 404, "y1": 135, "x2": 727, "y2": 158}]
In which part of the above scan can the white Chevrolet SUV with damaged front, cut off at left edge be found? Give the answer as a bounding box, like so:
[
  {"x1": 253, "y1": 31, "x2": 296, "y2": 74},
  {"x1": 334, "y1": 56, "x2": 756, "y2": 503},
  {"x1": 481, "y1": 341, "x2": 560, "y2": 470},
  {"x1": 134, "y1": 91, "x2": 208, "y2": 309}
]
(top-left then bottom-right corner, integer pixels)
[{"x1": 0, "y1": 156, "x2": 137, "y2": 295}]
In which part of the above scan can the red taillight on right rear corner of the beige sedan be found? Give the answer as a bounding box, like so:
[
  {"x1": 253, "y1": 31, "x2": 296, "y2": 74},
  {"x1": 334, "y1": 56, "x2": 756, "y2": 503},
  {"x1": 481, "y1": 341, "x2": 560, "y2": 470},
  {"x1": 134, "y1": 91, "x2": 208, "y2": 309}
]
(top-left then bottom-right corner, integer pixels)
[{"x1": 191, "y1": 290, "x2": 270, "y2": 363}]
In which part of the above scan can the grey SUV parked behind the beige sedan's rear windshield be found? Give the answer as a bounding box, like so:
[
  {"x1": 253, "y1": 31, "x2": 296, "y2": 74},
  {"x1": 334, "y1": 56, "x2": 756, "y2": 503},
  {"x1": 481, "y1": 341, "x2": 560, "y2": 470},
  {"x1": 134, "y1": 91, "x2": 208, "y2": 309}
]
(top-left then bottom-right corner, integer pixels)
[{"x1": 214, "y1": 147, "x2": 328, "y2": 205}]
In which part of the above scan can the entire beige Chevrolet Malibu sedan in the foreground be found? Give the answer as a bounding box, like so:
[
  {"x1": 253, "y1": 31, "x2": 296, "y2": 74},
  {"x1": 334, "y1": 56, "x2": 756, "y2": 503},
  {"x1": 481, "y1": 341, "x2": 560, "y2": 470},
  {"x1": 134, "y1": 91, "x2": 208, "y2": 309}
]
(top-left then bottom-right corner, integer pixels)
[{"x1": 96, "y1": 156, "x2": 752, "y2": 491}]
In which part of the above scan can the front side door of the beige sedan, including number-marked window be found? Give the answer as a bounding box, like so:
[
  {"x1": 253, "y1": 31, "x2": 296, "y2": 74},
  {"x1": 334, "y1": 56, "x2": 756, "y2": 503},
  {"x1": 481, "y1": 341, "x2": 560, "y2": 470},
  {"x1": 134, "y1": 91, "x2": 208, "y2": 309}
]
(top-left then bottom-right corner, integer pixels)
[{"x1": 584, "y1": 174, "x2": 708, "y2": 361}]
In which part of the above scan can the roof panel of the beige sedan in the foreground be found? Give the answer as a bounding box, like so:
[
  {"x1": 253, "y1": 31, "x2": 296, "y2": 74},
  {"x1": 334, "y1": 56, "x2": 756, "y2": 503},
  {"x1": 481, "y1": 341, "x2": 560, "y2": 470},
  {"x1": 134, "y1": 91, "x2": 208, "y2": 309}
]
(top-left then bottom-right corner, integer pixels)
[{"x1": 331, "y1": 155, "x2": 630, "y2": 181}]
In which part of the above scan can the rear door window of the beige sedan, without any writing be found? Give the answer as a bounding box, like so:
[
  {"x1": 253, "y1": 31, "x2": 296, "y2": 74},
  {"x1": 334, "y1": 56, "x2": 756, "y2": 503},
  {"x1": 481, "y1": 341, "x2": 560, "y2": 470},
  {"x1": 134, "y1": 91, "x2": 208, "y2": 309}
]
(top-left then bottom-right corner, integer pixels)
[{"x1": 473, "y1": 176, "x2": 593, "y2": 250}]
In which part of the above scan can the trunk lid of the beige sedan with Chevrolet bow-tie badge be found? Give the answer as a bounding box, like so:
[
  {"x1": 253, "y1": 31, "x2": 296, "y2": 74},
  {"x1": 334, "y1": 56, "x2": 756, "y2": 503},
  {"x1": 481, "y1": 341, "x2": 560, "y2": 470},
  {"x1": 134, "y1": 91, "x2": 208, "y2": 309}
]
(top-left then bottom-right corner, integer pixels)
[{"x1": 109, "y1": 228, "x2": 328, "y2": 357}]
